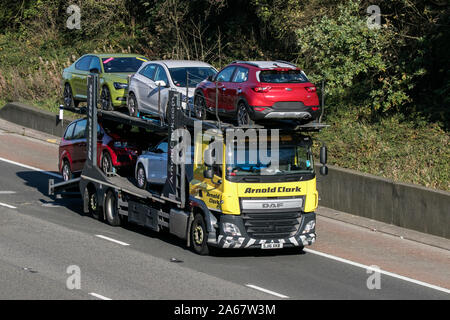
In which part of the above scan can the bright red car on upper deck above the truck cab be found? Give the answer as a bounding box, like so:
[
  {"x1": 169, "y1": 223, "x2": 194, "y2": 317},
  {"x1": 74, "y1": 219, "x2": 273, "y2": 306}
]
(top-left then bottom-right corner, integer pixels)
[{"x1": 194, "y1": 61, "x2": 321, "y2": 125}]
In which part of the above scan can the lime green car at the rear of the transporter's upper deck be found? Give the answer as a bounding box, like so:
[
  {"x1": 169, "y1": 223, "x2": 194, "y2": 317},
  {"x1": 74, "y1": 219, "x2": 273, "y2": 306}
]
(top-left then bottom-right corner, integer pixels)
[{"x1": 63, "y1": 53, "x2": 148, "y2": 110}]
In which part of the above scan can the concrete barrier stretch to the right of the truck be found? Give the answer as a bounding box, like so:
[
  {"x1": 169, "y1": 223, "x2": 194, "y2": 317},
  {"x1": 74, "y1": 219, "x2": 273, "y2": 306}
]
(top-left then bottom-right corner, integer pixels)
[{"x1": 317, "y1": 166, "x2": 450, "y2": 238}]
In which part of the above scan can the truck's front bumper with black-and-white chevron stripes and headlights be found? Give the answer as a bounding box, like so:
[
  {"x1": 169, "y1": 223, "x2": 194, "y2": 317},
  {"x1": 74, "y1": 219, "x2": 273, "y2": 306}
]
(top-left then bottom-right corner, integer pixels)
[{"x1": 208, "y1": 212, "x2": 316, "y2": 249}]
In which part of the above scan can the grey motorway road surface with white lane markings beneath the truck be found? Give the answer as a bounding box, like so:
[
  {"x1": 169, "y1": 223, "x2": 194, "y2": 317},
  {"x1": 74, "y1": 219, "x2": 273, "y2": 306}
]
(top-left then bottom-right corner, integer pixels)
[{"x1": 0, "y1": 132, "x2": 450, "y2": 299}]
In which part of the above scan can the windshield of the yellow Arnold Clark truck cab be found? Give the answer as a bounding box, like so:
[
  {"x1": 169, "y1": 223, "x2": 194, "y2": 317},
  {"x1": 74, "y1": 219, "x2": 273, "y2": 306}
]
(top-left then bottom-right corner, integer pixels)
[{"x1": 226, "y1": 135, "x2": 314, "y2": 176}]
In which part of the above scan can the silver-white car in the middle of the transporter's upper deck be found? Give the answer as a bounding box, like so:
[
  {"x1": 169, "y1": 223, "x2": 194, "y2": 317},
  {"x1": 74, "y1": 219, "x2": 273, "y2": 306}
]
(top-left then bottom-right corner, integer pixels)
[{"x1": 127, "y1": 60, "x2": 217, "y2": 118}]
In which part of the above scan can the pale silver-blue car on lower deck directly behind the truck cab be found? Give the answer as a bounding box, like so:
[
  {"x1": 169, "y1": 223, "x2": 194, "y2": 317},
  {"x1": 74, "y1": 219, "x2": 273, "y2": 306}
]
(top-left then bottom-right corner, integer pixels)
[{"x1": 135, "y1": 138, "x2": 194, "y2": 189}]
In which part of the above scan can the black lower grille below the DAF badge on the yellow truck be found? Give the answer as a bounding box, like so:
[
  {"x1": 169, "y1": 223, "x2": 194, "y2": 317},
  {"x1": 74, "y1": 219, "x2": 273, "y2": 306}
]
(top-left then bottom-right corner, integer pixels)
[{"x1": 242, "y1": 212, "x2": 301, "y2": 239}]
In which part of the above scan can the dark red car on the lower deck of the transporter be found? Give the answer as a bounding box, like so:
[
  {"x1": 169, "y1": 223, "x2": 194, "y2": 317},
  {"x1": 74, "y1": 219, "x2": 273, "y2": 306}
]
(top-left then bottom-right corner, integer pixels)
[{"x1": 59, "y1": 119, "x2": 142, "y2": 181}]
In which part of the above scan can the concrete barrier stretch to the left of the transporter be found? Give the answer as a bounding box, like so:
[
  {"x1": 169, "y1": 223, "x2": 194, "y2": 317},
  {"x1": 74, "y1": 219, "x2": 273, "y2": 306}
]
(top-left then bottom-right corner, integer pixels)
[{"x1": 0, "y1": 102, "x2": 70, "y2": 137}]
